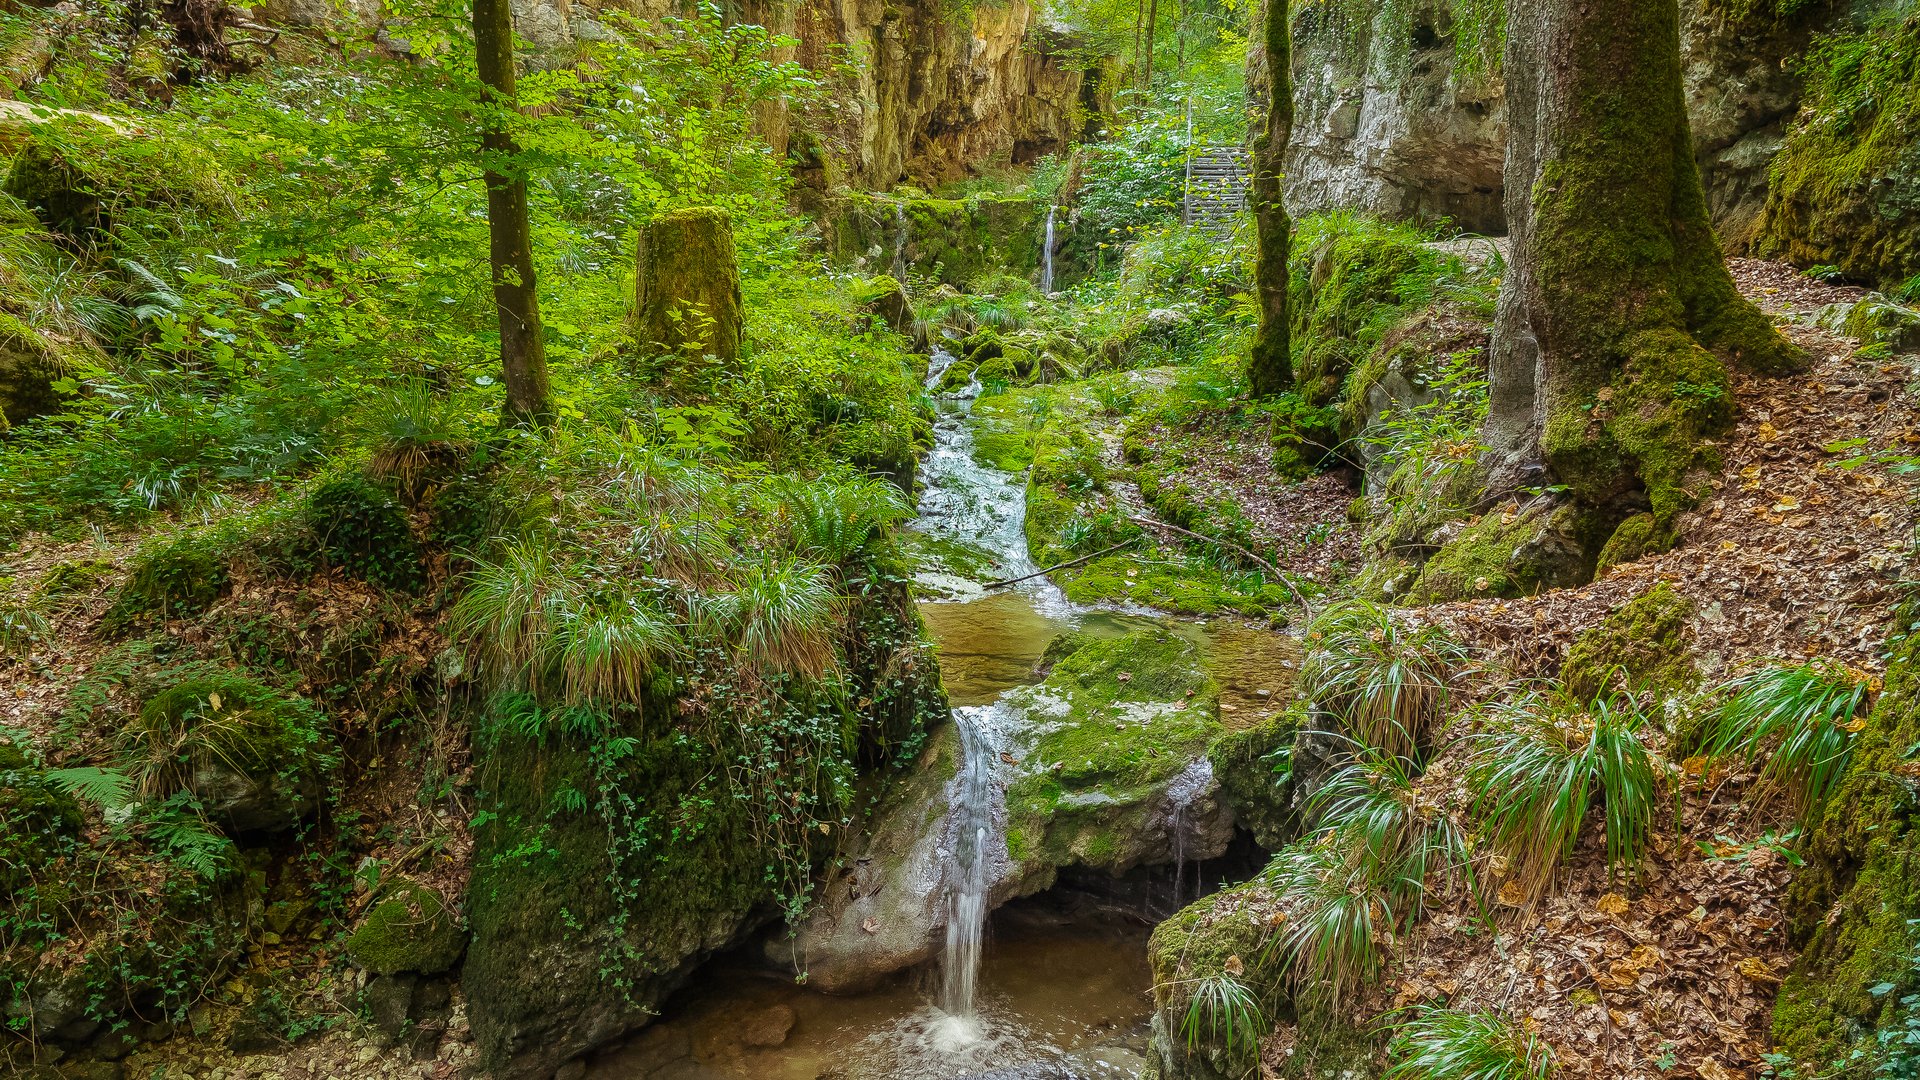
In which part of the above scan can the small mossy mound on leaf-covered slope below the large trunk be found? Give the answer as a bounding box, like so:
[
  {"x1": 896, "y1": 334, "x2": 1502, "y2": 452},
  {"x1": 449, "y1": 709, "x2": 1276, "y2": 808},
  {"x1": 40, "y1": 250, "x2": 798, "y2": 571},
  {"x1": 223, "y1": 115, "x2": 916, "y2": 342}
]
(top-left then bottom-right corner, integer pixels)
[{"x1": 1561, "y1": 582, "x2": 1695, "y2": 700}]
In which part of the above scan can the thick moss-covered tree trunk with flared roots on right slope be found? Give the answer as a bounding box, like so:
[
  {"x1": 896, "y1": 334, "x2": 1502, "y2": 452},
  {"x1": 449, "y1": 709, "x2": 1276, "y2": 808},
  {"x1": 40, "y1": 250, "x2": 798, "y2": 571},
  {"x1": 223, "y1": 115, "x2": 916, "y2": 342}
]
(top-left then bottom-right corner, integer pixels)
[{"x1": 1488, "y1": 0, "x2": 1801, "y2": 536}]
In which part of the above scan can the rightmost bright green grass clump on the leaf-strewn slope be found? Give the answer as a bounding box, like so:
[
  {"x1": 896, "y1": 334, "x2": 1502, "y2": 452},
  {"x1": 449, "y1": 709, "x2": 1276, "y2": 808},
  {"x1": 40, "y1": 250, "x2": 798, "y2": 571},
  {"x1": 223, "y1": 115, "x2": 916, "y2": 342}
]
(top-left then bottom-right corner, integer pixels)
[{"x1": 1705, "y1": 661, "x2": 1872, "y2": 817}]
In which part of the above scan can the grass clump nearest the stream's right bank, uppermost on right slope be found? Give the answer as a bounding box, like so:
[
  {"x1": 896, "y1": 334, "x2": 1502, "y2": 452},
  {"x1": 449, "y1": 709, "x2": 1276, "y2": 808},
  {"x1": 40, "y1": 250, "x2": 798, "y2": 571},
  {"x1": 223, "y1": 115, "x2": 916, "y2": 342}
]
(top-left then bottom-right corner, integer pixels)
[{"x1": 1300, "y1": 601, "x2": 1467, "y2": 759}]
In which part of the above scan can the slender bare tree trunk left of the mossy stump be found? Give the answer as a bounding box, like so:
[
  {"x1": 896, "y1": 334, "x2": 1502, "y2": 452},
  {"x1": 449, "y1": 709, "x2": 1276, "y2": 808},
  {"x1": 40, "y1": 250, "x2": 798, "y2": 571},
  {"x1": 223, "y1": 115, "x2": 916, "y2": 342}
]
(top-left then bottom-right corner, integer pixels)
[{"x1": 474, "y1": 0, "x2": 549, "y2": 425}]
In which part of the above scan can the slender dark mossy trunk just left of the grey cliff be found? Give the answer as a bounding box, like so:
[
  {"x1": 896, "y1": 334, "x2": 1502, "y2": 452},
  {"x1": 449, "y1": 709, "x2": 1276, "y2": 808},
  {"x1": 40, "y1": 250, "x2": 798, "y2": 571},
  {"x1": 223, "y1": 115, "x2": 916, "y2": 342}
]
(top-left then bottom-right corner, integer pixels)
[{"x1": 1246, "y1": 0, "x2": 1294, "y2": 398}]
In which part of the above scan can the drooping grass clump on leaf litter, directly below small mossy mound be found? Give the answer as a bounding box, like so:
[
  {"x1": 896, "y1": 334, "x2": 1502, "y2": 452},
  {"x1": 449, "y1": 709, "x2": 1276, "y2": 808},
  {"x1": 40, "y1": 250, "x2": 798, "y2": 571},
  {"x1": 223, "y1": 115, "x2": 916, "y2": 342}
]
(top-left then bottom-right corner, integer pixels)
[{"x1": 1467, "y1": 694, "x2": 1659, "y2": 907}]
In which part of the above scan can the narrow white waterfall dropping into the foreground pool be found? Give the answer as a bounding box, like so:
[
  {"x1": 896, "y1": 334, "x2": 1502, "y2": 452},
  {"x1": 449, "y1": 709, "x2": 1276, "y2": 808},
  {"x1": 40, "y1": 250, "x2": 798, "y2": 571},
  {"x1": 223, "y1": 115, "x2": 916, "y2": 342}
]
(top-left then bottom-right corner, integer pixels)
[{"x1": 941, "y1": 707, "x2": 996, "y2": 1020}]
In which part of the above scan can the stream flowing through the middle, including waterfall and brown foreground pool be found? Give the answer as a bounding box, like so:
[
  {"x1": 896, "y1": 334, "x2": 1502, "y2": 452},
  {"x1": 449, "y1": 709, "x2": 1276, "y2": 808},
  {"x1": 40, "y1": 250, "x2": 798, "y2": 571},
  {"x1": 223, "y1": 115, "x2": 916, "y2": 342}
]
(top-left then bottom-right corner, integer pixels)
[{"x1": 588, "y1": 352, "x2": 1231, "y2": 1080}]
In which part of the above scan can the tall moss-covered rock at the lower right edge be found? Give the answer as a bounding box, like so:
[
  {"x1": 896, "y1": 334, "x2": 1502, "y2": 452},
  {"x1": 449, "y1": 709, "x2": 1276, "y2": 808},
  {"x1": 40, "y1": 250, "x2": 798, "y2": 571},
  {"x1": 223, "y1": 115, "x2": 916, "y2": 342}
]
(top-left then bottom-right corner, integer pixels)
[{"x1": 1774, "y1": 634, "x2": 1920, "y2": 1080}]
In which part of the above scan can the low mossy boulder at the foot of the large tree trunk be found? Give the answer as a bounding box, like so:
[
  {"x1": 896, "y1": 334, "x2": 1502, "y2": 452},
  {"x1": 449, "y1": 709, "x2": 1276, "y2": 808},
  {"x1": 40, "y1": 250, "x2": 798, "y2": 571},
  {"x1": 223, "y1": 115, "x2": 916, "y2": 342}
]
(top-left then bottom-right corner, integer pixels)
[{"x1": 1407, "y1": 502, "x2": 1599, "y2": 603}]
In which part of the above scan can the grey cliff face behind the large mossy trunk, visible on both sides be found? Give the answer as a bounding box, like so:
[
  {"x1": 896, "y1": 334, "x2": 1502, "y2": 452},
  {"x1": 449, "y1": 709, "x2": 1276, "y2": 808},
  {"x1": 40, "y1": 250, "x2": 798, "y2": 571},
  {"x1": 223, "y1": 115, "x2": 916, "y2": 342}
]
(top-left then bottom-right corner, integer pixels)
[{"x1": 1286, "y1": 0, "x2": 1818, "y2": 250}]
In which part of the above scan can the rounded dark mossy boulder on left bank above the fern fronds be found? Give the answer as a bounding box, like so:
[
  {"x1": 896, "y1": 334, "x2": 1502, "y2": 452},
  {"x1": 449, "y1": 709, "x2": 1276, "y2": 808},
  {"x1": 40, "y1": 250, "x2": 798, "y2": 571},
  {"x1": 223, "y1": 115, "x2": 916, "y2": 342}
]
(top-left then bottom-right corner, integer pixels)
[{"x1": 123, "y1": 675, "x2": 340, "y2": 832}]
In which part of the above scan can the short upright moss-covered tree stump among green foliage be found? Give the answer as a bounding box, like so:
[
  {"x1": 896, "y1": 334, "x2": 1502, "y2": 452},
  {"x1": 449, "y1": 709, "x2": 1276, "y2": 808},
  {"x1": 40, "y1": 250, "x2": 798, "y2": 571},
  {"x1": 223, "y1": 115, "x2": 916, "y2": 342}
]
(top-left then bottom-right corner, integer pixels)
[{"x1": 634, "y1": 206, "x2": 743, "y2": 361}]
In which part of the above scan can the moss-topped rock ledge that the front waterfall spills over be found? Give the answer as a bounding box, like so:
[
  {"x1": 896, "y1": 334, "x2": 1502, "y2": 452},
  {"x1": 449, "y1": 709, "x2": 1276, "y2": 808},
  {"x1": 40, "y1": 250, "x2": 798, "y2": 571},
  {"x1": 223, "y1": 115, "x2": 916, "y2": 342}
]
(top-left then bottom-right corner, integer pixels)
[{"x1": 766, "y1": 630, "x2": 1233, "y2": 994}]
